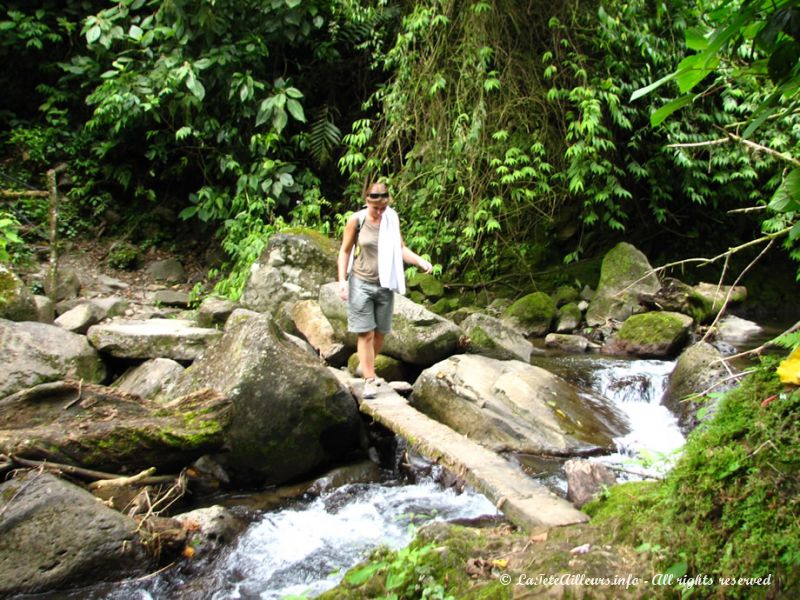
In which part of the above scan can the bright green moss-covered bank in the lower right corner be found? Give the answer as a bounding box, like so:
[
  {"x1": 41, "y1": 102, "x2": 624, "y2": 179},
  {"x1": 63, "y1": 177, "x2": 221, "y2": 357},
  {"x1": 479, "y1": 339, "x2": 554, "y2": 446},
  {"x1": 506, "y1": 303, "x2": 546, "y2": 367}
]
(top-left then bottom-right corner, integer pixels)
[{"x1": 586, "y1": 359, "x2": 800, "y2": 598}]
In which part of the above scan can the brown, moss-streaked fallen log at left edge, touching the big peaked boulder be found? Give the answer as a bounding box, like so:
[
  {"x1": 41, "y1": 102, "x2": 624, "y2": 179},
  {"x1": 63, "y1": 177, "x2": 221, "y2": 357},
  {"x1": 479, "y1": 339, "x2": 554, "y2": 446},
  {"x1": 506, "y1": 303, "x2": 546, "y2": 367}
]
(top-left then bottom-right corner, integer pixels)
[{"x1": 0, "y1": 381, "x2": 230, "y2": 473}]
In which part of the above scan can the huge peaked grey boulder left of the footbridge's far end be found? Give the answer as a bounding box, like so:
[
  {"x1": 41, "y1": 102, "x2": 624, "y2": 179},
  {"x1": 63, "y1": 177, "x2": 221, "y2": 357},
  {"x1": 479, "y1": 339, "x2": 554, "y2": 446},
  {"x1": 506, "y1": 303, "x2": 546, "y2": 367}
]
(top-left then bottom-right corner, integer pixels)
[{"x1": 171, "y1": 313, "x2": 362, "y2": 484}]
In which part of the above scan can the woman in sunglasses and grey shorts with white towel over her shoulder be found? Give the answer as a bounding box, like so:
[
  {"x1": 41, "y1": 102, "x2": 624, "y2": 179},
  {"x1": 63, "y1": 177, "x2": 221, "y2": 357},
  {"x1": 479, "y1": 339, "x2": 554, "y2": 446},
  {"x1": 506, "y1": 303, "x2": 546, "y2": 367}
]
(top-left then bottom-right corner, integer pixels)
[{"x1": 337, "y1": 182, "x2": 433, "y2": 398}]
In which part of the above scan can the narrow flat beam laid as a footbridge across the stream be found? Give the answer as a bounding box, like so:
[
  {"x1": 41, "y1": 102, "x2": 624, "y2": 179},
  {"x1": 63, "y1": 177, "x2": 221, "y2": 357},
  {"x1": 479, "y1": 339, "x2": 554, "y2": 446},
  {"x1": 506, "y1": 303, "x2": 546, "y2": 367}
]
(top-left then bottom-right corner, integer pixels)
[{"x1": 352, "y1": 380, "x2": 589, "y2": 532}]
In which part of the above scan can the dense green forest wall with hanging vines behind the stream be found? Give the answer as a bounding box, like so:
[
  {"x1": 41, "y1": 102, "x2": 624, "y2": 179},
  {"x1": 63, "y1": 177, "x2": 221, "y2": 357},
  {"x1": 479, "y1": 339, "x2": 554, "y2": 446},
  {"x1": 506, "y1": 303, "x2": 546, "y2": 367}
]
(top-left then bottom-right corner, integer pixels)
[{"x1": 0, "y1": 0, "x2": 800, "y2": 310}]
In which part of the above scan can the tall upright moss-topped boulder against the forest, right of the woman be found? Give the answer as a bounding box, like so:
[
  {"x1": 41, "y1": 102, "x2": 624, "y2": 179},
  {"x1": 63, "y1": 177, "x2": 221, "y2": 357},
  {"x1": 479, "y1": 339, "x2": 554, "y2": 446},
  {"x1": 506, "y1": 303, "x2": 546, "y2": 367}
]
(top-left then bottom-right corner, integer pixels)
[{"x1": 586, "y1": 242, "x2": 661, "y2": 327}]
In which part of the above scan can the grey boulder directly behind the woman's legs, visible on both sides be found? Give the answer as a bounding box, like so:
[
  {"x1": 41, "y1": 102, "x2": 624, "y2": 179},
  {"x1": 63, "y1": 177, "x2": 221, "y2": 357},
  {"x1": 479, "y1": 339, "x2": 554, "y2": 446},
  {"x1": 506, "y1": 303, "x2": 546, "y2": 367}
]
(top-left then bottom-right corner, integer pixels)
[{"x1": 319, "y1": 283, "x2": 463, "y2": 367}]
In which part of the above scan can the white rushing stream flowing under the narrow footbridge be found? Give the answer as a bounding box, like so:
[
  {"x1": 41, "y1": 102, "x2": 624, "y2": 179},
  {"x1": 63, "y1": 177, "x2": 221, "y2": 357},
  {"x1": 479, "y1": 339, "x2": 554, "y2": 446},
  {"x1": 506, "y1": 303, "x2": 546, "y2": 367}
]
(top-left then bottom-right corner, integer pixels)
[{"x1": 69, "y1": 316, "x2": 780, "y2": 600}]
